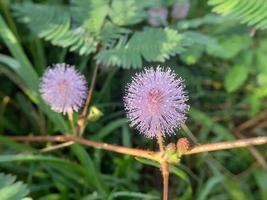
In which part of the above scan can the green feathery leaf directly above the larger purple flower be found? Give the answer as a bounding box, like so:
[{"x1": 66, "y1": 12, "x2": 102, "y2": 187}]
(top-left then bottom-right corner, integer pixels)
[{"x1": 96, "y1": 28, "x2": 191, "y2": 68}]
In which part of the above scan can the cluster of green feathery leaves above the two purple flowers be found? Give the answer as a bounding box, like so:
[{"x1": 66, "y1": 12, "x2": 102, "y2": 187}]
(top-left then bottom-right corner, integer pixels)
[{"x1": 11, "y1": 0, "x2": 194, "y2": 68}]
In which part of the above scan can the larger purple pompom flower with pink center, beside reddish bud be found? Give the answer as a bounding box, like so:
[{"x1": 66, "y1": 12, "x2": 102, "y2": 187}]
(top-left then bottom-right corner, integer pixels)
[{"x1": 124, "y1": 67, "x2": 189, "y2": 138}]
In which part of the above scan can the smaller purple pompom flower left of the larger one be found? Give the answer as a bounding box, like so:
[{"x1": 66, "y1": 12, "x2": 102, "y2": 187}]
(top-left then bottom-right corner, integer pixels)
[{"x1": 40, "y1": 63, "x2": 87, "y2": 114}]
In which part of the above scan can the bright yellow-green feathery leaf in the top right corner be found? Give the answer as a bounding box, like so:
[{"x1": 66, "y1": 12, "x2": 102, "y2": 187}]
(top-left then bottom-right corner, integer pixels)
[{"x1": 208, "y1": 0, "x2": 267, "y2": 29}]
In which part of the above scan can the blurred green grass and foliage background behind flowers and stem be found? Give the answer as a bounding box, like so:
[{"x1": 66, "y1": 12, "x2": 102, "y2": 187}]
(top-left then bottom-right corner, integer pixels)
[{"x1": 0, "y1": 0, "x2": 267, "y2": 200}]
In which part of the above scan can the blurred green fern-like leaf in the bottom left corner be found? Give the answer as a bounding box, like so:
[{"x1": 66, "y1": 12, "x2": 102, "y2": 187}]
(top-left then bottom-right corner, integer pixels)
[{"x1": 0, "y1": 173, "x2": 30, "y2": 200}]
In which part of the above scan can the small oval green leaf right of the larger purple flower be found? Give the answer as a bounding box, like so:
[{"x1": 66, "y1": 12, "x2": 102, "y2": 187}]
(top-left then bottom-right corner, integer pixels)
[{"x1": 224, "y1": 65, "x2": 248, "y2": 92}]
